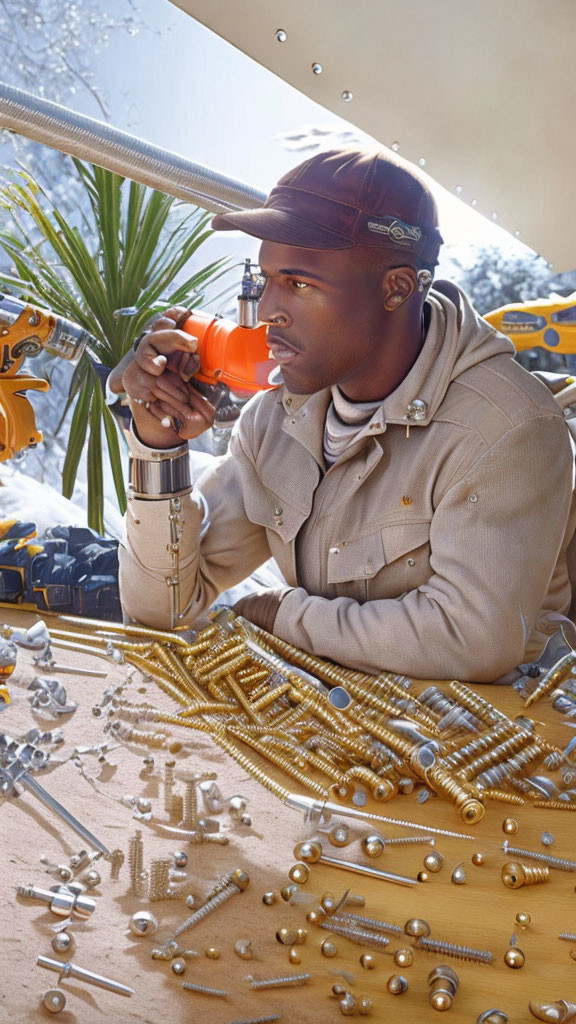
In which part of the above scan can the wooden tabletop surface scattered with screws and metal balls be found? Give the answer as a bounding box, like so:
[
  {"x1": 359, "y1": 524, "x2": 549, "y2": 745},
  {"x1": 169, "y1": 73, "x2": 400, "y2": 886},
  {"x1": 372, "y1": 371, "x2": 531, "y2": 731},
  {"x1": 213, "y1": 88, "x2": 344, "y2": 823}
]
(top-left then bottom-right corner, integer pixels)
[{"x1": 0, "y1": 608, "x2": 576, "y2": 1024}]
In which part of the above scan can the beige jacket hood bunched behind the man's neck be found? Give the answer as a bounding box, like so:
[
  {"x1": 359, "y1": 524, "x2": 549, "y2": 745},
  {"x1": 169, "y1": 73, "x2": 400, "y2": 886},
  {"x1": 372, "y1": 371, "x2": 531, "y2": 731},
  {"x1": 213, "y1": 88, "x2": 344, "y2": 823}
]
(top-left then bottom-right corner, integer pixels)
[{"x1": 282, "y1": 281, "x2": 515, "y2": 429}]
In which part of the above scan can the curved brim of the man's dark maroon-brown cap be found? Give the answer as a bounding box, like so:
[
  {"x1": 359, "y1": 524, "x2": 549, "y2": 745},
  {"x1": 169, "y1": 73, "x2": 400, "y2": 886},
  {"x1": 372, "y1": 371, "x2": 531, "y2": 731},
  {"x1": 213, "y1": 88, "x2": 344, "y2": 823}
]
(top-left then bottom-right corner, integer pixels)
[{"x1": 212, "y1": 208, "x2": 356, "y2": 249}]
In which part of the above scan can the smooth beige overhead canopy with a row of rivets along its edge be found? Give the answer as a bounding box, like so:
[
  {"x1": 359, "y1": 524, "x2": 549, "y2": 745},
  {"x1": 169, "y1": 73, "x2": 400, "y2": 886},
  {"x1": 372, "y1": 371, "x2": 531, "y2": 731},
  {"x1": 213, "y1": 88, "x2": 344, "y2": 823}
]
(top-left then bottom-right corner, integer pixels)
[{"x1": 170, "y1": 0, "x2": 576, "y2": 270}]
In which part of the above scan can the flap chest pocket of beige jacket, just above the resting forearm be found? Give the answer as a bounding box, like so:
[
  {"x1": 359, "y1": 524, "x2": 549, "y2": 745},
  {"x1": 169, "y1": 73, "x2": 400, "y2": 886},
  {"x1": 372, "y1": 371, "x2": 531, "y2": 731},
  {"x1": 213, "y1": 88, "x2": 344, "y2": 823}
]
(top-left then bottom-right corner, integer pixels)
[{"x1": 327, "y1": 521, "x2": 430, "y2": 600}]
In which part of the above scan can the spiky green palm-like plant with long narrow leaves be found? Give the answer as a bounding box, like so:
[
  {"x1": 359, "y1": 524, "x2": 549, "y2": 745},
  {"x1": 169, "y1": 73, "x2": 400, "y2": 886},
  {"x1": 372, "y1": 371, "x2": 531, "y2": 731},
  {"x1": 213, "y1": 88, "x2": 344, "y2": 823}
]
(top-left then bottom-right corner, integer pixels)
[{"x1": 0, "y1": 160, "x2": 227, "y2": 532}]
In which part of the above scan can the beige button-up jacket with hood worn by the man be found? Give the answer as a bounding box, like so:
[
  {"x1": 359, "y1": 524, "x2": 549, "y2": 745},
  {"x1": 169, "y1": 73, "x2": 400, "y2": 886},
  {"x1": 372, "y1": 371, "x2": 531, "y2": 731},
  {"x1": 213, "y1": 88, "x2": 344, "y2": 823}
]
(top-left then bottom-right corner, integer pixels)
[{"x1": 121, "y1": 284, "x2": 574, "y2": 681}]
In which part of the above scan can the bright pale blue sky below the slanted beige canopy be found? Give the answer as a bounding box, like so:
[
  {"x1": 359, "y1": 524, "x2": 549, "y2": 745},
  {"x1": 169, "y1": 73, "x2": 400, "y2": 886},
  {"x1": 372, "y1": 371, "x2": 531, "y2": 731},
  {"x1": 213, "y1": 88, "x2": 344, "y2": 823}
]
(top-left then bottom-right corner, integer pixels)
[{"x1": 71, "y1": 0, "x2": 527, "y2": 274}]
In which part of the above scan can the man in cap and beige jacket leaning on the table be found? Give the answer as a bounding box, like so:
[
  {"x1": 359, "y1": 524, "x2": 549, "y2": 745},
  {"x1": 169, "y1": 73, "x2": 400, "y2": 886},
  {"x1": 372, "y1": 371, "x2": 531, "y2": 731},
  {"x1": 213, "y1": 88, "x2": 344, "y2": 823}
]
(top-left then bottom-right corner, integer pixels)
[{"x1": 121, "y1": 151, "x2": 574, "y2": 682}]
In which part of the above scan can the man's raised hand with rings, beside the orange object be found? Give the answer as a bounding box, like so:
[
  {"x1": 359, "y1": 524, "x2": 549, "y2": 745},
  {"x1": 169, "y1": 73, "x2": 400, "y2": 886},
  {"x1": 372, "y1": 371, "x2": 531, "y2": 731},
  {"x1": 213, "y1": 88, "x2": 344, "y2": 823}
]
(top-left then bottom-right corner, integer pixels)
[{"x1": 122, "y1": 306, "x2": 214, "y2": 449}]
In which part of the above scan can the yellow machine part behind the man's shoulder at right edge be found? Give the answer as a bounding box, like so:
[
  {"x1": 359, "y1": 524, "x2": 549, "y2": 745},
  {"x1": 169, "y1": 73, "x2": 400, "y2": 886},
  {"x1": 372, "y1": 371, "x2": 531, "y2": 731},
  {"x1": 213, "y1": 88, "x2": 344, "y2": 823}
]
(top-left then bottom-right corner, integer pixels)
[{"x1": 484, "y1": 292, "x2": 576, "y2": 354}]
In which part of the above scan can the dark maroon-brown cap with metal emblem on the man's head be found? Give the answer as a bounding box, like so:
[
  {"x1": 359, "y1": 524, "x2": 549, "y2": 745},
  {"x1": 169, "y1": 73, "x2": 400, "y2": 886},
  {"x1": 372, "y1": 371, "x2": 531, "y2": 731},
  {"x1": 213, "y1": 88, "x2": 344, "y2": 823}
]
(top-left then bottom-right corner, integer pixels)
[{"x1": 212, "y1": 148, "x2": 442, "y2": 266}]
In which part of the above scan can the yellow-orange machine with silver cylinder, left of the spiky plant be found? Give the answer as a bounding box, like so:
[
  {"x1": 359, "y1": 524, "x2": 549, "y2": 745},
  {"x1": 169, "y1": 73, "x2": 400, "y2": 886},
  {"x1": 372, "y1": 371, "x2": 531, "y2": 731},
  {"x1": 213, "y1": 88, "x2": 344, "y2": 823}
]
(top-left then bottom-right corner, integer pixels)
[{"x1": 0, "y1": 295, "x2": 90, "y2": 462}]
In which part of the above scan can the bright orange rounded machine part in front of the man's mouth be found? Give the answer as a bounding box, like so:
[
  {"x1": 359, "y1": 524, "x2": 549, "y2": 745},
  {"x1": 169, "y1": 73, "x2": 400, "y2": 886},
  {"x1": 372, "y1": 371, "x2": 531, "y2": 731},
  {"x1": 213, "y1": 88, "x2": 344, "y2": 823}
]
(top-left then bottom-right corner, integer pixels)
[{"x1": 182, "y1": 312, "x2": 278, "y2": 394}]
